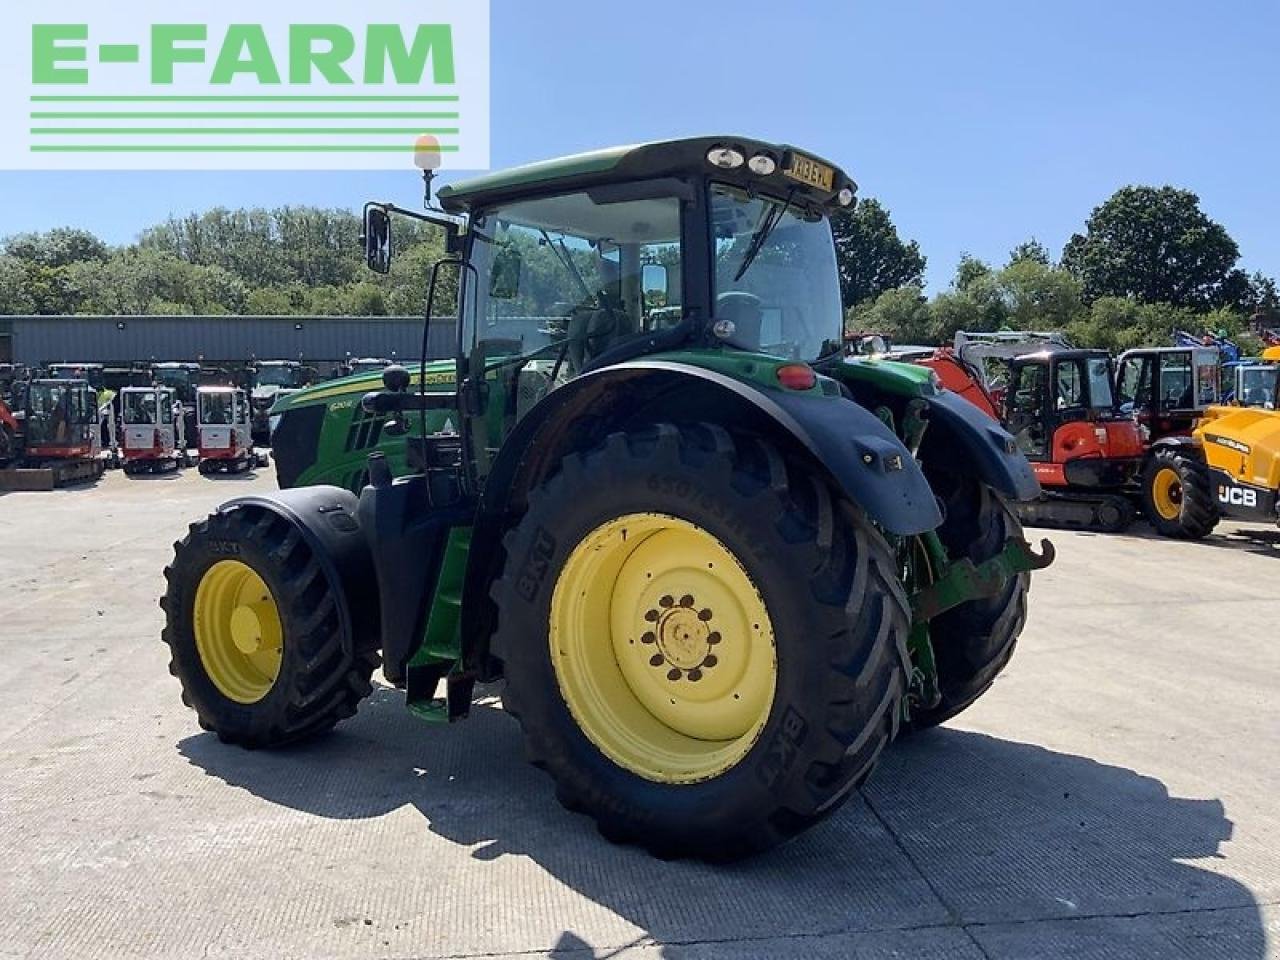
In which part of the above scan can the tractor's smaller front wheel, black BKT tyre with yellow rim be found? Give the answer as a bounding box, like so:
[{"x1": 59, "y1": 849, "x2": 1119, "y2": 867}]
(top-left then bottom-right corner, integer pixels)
[{"x1": 160, "y1": 507, "x2": 378, "y2": 748}]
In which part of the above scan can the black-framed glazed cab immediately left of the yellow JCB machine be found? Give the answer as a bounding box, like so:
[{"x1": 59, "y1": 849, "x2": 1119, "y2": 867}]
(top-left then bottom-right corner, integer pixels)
[{"x1": 1115, "y1": 347, "x2": 1222, "y2": 440}]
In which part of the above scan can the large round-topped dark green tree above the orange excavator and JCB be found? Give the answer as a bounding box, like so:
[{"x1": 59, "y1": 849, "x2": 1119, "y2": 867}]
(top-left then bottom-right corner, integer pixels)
[{"x1": 1062, "y1": 187, "x2": 1240, "y2": 310}]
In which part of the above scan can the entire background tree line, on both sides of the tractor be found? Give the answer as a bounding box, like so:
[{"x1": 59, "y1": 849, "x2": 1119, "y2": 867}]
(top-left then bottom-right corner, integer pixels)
[{"x1": 0, "y1": 186, "x2": 1280, "y2": 358}]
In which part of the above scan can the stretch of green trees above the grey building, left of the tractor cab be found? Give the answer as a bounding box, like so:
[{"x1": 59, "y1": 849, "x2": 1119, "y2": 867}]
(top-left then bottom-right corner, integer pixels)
[{"x1": 0, "y1": 207, "x2": 443, "y2": 316}]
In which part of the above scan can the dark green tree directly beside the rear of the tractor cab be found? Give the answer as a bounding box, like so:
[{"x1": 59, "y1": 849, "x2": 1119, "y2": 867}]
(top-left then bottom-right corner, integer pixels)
[{"x1": 831, "y1": 198, "x2": 925, "y2": 307}]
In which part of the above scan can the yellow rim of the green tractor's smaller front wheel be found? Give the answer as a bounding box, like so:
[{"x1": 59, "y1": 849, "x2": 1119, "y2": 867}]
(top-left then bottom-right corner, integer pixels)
[{"x1": 195, "y1": 561, "x2": 284, "y2": 704}]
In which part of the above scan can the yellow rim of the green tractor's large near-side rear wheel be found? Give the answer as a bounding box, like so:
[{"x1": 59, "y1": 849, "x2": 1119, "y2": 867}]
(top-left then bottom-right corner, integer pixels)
[{"x1": 549, "y1": 513, "x2": 777, "y2": 783}]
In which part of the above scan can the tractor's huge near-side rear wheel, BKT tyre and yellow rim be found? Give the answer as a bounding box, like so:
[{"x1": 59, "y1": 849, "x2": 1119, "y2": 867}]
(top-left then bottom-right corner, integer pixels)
[{"x1": 492, "y1": 424, "x2": 910, "y2": 860}]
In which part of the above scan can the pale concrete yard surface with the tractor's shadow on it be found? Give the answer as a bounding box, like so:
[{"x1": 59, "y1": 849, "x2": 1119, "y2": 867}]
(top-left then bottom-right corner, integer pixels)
[{"x1": 0, "y1": 470, "x2": 1280, "y2": 960}]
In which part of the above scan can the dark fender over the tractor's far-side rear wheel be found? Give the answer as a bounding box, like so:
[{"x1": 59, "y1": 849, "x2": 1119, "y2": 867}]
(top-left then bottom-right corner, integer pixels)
[{"x1": 924, "y1": 390, "x2": 1041, "y2": 500}]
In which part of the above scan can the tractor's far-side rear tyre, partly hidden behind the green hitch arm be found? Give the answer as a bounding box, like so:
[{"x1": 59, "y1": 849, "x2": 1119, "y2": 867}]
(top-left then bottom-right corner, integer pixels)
[{"x1": 906, "y1": 474, "x2": 1030, "y2": 731}]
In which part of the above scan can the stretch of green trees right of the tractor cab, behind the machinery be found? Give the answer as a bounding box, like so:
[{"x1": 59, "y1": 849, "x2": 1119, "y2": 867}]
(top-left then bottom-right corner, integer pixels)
[{"x1": 833, "y1": 186, "x2": 1280, "y2": 353}]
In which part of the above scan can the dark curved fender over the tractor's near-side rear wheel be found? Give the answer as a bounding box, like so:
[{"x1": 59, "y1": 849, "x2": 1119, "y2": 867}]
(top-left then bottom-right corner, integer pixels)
[{"x1": 462, "y1": 360, "x2": 942, "y2": 671}]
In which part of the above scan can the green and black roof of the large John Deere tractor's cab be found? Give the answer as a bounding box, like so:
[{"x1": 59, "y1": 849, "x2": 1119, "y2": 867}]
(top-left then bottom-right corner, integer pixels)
[{"x1": 436, "y1": 136, "x2": 858, "y2": 214}]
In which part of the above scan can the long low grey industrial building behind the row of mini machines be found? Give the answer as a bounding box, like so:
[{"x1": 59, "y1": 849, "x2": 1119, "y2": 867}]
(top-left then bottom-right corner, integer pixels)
[{"x1": 0, "y1": 316, "x2": 454, "y2": 366}]
